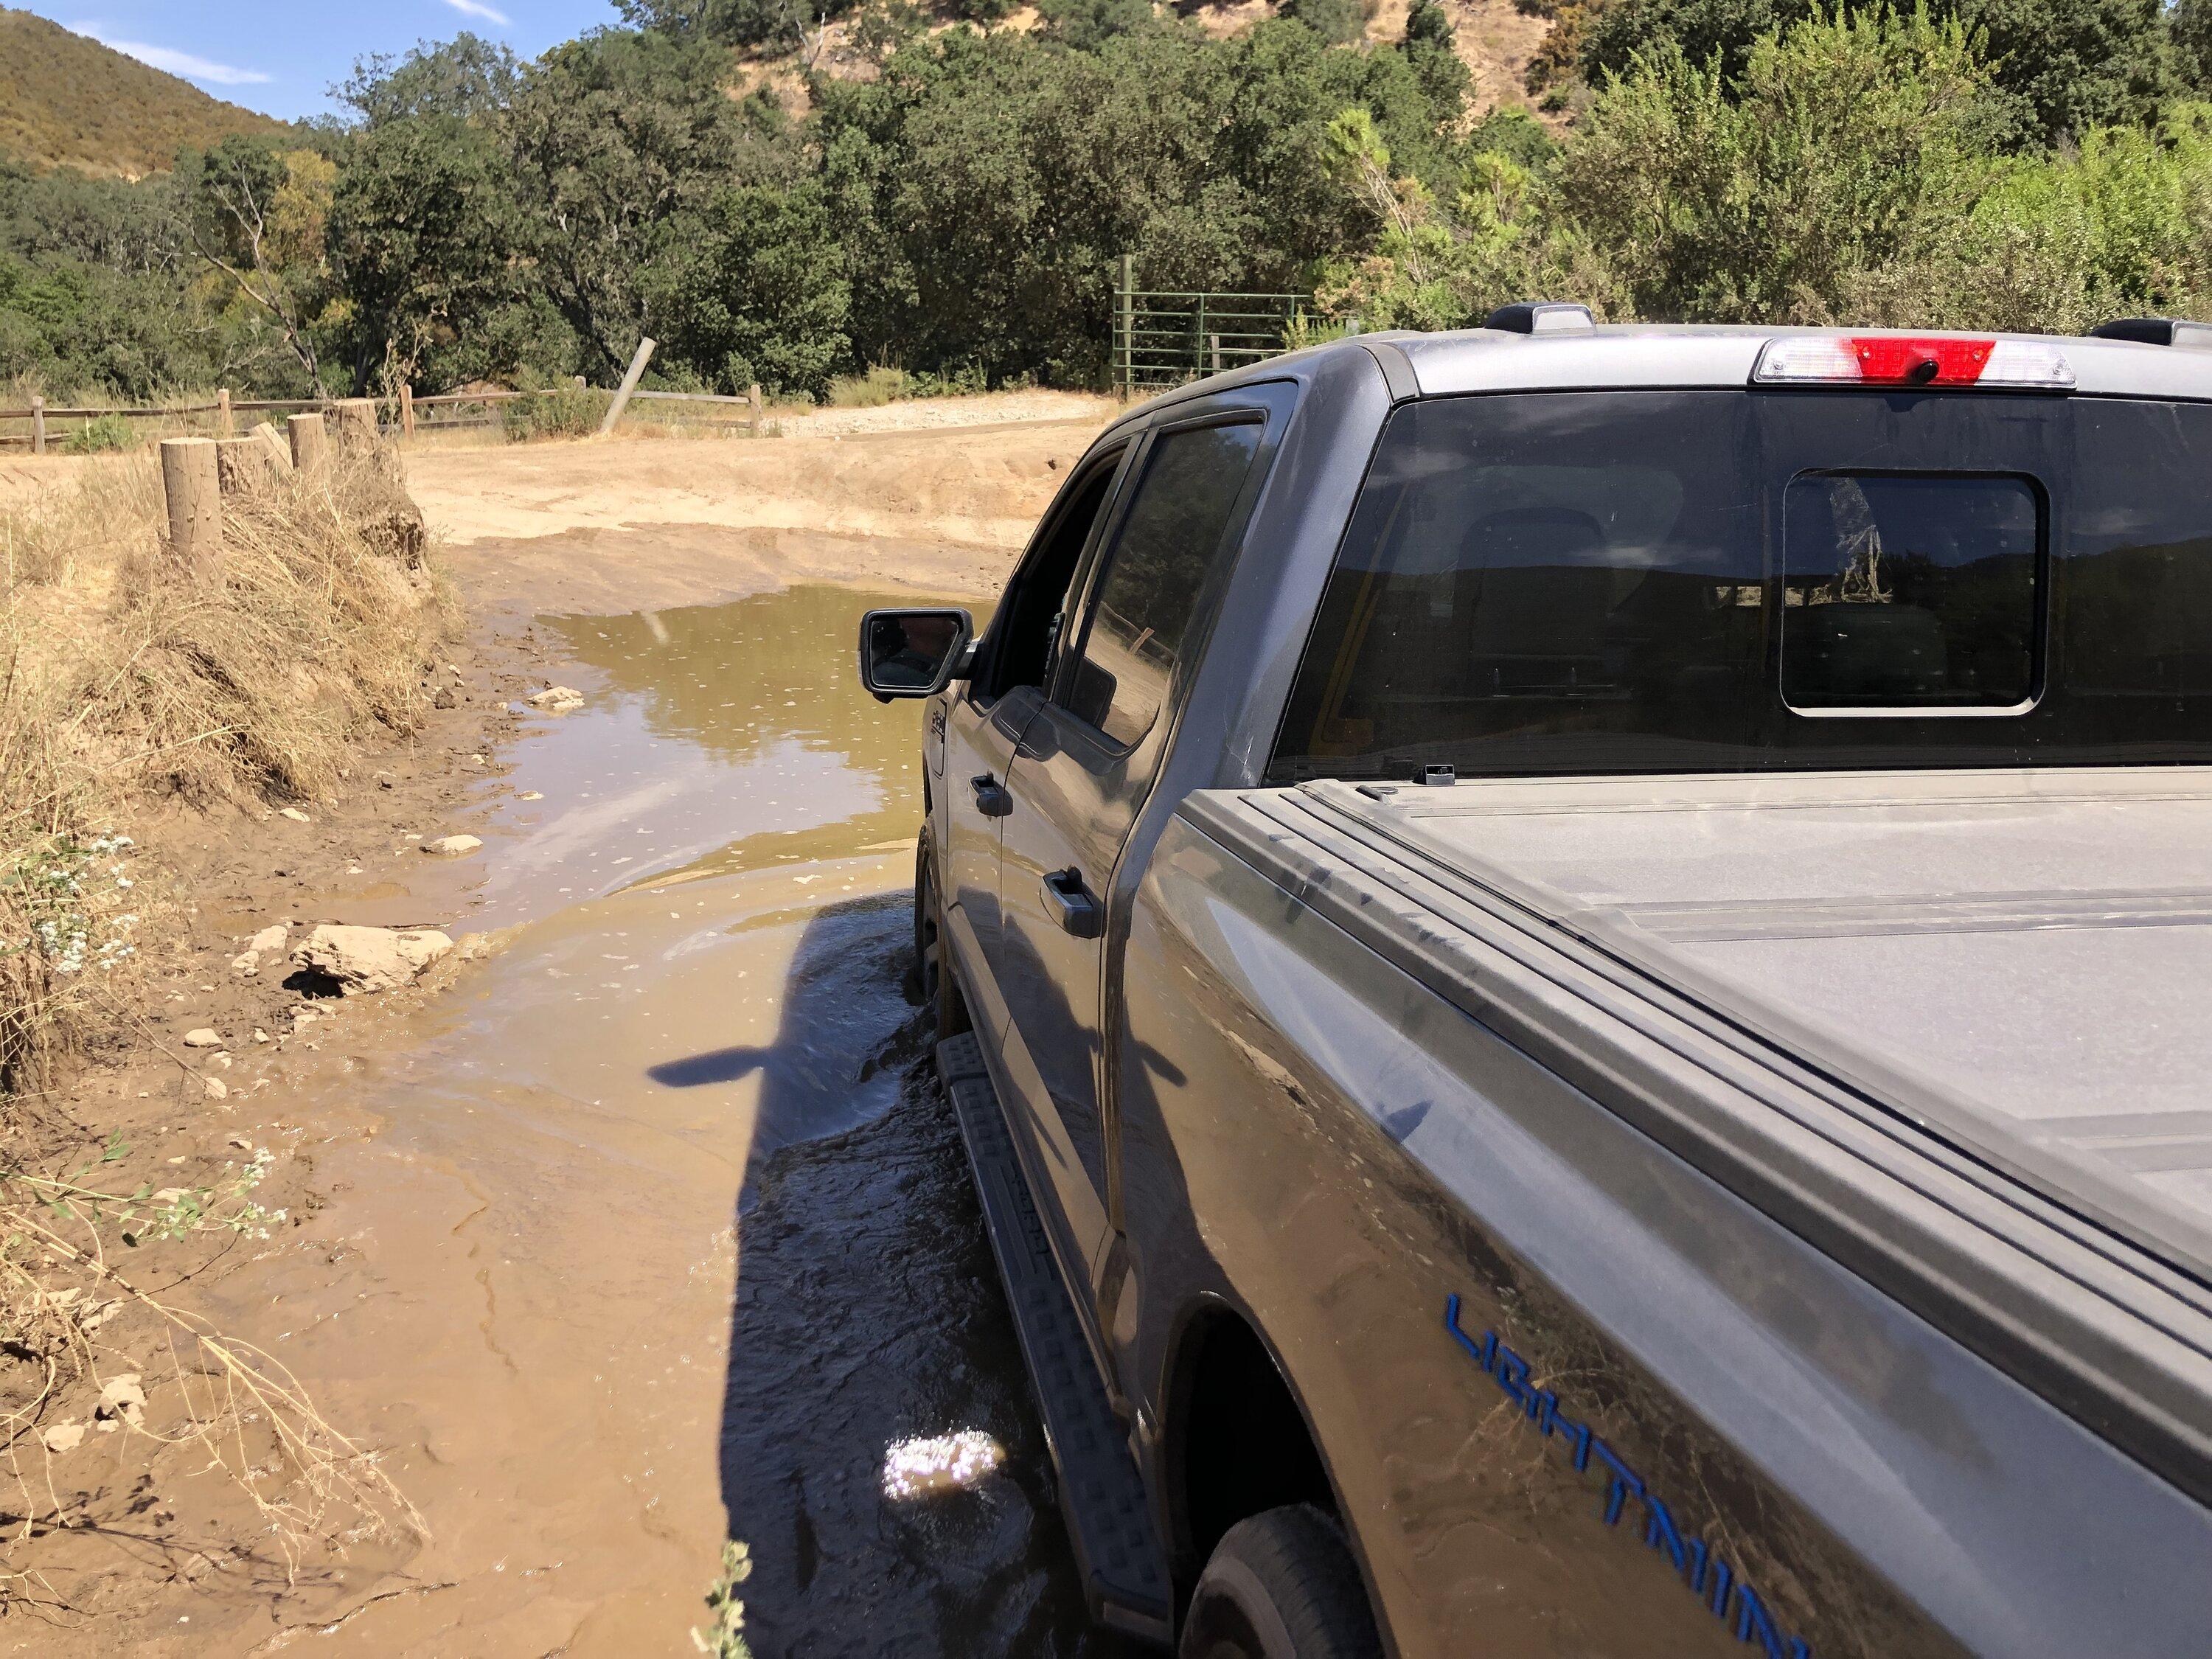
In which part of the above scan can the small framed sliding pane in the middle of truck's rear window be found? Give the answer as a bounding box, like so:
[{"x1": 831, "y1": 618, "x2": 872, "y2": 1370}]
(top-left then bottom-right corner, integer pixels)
[{"x1": 1783, "y1": 473, "x2": 2042, "y2": 708}]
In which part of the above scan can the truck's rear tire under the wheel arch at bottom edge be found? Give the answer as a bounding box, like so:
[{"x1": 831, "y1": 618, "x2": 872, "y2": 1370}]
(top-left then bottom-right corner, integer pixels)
[{"x1": 1177, "y1": 1504, "x2": 1382, "y2": 1659}]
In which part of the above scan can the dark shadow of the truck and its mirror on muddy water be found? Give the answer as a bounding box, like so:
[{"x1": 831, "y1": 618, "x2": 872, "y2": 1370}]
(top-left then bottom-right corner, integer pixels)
[{"x1": 648, "y1": 896, "x2": 1121, "y2": 1659}]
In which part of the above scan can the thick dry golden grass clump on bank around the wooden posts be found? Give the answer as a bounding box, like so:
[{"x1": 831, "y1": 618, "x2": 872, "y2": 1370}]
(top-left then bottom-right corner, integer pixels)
[{"x1": 0, "y1": 442, "x2": 453, "y2": 1093}]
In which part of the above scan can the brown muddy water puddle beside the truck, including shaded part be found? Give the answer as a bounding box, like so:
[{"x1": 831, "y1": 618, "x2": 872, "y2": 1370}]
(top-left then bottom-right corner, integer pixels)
[{"x1": 201, "y1": 588, "x2": 1133, "y2": 1659}]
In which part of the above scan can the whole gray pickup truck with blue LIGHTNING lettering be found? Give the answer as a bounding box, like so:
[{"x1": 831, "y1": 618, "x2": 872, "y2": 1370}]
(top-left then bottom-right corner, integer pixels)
[{"x1": 860, "y1": 305, "x2": 2212, "y2": 1659}]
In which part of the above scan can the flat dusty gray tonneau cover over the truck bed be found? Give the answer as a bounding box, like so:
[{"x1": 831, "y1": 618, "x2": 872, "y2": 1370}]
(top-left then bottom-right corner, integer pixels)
[{"x1": 1305, "y1": 768, "x2": 2212, "y2": 1281}]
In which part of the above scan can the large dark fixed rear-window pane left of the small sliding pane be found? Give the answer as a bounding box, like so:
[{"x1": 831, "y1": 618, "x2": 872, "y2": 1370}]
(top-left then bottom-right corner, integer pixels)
[{"x1": 1279, "y1": 394, "x2": 1765, "y2": 776}]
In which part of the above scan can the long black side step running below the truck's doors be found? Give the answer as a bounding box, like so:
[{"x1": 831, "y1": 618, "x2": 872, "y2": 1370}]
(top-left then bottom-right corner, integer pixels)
[{"x1": 938, "y1": 1035, "x2": 1175, "y2": 1644}]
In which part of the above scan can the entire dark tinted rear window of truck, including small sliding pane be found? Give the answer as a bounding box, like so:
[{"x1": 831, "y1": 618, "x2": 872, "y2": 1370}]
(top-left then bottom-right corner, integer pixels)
[{"x1": 1270, "y1": 392, "x2": 2212, "y2": 781}]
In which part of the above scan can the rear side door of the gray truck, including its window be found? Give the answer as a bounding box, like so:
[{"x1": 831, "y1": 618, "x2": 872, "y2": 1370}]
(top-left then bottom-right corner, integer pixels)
[{"x1": 1002, "y1": 409, "x2": 1265, "y2": 1283}]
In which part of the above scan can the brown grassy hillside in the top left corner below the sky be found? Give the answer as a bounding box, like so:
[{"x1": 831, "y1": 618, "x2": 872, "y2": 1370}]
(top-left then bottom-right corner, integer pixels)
[{"x1": 0, "y1": 9, "x2": 283, "y2": 177}]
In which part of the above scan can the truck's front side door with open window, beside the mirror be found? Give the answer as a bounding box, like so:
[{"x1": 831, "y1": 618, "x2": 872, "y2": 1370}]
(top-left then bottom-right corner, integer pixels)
[{"x1": 933, "y1": 456, "x2": 1128, "y2": 1033}]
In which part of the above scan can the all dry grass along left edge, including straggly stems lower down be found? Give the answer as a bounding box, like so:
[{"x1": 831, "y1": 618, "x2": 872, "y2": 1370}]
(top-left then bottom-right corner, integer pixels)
[{"x1": 0, "y1": 436, "x2": 453, "y2": 1613}]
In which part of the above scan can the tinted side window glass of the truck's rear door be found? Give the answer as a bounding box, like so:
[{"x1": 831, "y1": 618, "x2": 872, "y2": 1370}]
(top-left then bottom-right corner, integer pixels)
[{"x1": 1066, "y1": 420, "x2": 1261, "y2": 748}]
